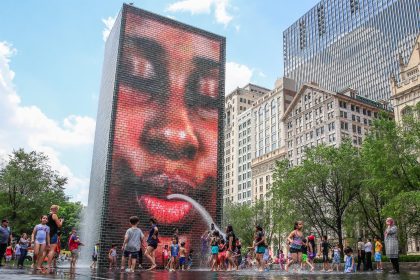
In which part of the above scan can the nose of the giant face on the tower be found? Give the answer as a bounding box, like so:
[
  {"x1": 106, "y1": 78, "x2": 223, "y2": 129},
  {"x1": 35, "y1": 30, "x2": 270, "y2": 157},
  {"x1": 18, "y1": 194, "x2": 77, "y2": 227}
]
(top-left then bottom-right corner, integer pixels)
[{"x1": 140, "y1": 95, "x2": 199, "y2": 160}]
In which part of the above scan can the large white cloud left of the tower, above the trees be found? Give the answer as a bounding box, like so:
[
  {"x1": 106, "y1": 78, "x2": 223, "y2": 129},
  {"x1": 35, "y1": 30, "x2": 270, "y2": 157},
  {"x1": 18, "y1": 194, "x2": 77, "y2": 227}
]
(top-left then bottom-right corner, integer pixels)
[{"x1": 0, "y1": 42, "x2": 95, "y2": 204}]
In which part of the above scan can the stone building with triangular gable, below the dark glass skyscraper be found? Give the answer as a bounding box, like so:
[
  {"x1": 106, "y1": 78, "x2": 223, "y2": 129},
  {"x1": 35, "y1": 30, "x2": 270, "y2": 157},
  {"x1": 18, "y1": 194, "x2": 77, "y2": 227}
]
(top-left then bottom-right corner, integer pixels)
[{"x1": 282, "y1": 83, "x2": 390, "y2": 166}]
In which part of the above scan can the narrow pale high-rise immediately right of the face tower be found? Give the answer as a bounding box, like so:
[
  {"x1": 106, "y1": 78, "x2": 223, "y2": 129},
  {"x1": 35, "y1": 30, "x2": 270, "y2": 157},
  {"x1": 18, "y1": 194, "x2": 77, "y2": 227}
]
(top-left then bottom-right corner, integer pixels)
[{"x1": 223, "y1": 84, "x2": 270, "y2": 203}]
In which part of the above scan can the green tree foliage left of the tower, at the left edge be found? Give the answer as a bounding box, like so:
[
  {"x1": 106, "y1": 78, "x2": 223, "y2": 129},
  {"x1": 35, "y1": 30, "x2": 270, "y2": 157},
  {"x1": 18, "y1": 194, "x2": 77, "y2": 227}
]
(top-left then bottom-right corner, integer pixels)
[{"x1": 0, "y1": 149, "x2": 82, "y2": 247}]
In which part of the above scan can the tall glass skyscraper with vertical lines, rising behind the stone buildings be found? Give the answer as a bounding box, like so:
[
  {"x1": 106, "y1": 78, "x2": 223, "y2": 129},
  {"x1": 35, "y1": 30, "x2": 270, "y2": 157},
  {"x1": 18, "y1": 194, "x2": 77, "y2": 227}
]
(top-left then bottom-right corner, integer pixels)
[{"x1": 283, "y1": 0, "x2": 420, "y2": 100}]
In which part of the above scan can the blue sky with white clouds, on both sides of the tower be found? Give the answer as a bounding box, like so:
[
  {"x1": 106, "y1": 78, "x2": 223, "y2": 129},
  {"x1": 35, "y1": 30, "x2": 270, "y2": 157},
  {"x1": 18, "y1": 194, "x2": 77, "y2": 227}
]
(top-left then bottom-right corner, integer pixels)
[{"x1": 0, "y1": 0, "x2": 319, "y2": 203}]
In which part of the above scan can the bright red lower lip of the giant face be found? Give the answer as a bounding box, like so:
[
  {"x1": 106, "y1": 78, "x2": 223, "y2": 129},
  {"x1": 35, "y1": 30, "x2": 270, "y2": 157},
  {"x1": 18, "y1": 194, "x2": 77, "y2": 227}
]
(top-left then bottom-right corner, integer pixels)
[{"x1": 137, "y1": 195, "x2": 192, "y2": 224}]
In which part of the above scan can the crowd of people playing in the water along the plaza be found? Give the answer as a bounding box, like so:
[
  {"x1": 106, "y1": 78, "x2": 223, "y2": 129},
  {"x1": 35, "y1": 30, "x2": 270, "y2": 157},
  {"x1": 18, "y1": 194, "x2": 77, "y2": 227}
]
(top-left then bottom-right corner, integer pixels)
[{"x1": 0, "y1": 205, "x2": 399, "y2": 273}]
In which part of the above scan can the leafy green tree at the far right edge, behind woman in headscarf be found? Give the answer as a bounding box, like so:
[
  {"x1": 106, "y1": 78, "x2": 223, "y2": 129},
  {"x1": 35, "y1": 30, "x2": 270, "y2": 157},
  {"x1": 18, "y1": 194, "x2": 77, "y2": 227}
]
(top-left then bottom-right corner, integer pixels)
[{"x1": 358, "y1": 110, "x2": 420, "y2": 252}]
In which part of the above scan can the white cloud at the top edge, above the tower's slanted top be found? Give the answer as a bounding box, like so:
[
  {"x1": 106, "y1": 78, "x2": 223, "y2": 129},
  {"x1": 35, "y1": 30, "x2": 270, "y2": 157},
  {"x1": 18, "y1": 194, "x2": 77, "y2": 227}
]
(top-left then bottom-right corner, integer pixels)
[{"x1": 167, "y1": 0, "x2": 233, "y2": 26}]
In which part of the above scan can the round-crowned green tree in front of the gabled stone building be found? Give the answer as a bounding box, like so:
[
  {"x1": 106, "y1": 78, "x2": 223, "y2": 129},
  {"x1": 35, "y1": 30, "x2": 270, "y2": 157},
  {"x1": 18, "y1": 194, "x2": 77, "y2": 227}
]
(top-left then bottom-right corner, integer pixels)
[{"x1": 273, "y1": 141, "x2": 362, "y2": 253}]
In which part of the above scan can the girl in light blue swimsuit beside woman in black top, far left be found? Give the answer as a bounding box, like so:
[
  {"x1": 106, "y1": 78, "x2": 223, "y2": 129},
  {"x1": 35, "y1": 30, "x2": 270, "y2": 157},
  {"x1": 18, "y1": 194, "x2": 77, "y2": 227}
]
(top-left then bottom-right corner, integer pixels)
[{"x1": 32, "y1": 215, "x2": 50, "y2": 270}]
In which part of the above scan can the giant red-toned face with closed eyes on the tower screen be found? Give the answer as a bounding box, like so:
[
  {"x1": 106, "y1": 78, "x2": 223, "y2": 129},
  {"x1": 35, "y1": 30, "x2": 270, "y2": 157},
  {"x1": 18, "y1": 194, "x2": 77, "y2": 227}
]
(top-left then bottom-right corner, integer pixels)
[{"x1": 109, "y1": 7, "x2": 224, "y2": 260}]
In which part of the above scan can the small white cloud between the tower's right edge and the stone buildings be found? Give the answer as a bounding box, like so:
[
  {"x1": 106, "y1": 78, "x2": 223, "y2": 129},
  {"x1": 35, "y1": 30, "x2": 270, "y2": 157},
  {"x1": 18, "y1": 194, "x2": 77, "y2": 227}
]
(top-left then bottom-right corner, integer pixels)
[{"x1": 225, "y1": 62, "x2": 254, "y2": 94}]
